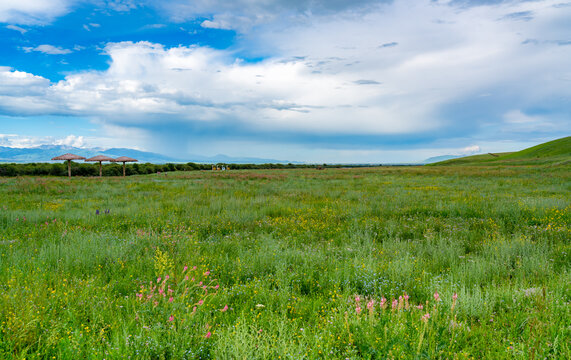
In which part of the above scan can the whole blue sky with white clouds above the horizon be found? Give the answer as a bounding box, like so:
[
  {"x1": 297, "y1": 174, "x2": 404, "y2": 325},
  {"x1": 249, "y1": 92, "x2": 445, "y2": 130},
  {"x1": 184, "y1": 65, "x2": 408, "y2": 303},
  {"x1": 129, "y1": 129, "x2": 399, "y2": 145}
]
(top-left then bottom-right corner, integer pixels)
[{"x1": 0, "y1": 0, "x2": 571, "y2": 163}]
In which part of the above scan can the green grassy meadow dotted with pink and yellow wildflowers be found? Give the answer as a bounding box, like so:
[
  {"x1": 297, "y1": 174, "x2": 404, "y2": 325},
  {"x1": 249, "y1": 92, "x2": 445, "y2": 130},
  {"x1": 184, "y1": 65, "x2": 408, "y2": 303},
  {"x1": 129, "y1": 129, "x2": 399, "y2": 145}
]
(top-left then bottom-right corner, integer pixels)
[{"x1": 0, "y1": 165, "x2": 571, "y2": 359}]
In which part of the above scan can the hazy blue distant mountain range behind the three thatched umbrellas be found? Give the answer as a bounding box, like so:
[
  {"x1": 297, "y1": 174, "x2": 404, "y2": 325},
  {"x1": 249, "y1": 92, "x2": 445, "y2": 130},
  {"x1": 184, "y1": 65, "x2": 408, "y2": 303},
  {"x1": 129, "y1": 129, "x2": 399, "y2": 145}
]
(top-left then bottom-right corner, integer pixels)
[{"x1": 0, "y1": 145, "x2": 299, "y2": 164}]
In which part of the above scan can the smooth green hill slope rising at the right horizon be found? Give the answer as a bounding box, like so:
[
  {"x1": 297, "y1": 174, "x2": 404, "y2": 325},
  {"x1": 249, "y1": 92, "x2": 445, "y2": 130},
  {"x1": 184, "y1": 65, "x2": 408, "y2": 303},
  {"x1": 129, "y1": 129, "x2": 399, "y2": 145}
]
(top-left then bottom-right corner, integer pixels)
[{"x1": 428, "y1": 136, "x2": 571, "y2": 166}]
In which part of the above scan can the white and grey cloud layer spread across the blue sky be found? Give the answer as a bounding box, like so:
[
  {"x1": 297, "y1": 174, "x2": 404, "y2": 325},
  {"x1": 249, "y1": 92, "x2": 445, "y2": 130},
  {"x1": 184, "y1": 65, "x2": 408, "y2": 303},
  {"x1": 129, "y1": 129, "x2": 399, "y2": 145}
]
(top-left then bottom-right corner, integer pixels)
[{"x1": 0, "y1": 0, "x2": 571, "y2": 160}]
